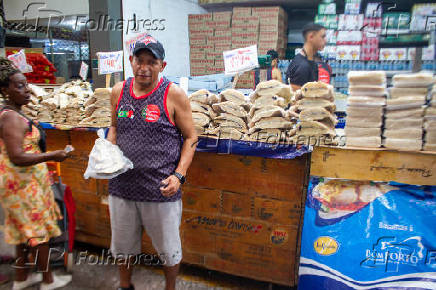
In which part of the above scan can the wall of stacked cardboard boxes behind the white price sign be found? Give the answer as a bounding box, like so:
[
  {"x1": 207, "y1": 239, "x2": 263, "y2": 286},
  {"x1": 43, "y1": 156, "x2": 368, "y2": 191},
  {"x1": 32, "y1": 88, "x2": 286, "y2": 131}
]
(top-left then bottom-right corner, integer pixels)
[{"x1": 188, "y1": 6, "x2": 288, "y2": 88}]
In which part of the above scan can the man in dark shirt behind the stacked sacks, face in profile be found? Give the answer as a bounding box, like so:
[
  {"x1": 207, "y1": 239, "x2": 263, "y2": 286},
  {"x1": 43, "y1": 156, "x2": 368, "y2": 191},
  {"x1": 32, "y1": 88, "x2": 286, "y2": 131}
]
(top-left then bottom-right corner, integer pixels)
[{"x1": 286, "y1": 23, "x2": 326, "y2": 91}]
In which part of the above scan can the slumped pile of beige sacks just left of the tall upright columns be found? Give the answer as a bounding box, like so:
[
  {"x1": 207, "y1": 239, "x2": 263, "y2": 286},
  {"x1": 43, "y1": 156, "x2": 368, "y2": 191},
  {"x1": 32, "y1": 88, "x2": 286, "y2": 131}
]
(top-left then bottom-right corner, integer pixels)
[{"x1": 291, "y1": 82, "x2": 337, "y2": 141}]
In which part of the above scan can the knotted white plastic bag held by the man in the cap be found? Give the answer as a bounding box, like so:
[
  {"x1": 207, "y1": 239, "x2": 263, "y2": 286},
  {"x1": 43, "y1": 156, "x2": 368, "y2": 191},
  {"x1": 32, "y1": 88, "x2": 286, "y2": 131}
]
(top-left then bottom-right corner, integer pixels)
[{"x1": 83, "y1": 129, "x2": 133, "y2": 179}]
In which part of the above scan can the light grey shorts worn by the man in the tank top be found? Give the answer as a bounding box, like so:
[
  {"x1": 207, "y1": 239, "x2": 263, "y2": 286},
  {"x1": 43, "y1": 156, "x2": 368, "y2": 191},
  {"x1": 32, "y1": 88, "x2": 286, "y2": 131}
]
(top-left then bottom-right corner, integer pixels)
[{"x1": 109, "y1": 195, "x2": 182, "y2": 267}]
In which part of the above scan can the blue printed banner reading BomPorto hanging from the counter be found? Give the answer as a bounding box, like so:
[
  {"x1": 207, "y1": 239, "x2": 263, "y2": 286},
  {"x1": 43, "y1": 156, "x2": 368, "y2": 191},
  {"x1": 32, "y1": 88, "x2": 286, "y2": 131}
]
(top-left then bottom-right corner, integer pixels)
[{"x1": 298, "y1": 177, "x2": 436, "y2": 290}]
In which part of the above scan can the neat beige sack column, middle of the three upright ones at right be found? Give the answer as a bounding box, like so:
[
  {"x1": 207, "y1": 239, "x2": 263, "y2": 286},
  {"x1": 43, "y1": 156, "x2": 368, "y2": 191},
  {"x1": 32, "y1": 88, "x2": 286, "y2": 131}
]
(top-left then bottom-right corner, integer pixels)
[{"x1": 383, "y1": 73, "x2": 433, "y2": 151}]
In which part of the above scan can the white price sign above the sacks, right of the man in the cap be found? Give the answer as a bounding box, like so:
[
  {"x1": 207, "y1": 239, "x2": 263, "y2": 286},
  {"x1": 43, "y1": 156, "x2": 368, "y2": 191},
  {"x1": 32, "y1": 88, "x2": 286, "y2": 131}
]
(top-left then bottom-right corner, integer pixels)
[{"x1": 223, "y1": 45, "x2": 259, "y2": 75}]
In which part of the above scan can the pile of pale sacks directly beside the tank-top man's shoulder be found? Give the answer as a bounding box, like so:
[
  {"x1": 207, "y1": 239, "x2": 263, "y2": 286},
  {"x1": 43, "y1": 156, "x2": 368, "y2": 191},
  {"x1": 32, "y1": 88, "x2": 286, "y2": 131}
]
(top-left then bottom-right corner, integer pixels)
[{"x1": 188, "y1": 89, "x2": 219, "y2": 135}]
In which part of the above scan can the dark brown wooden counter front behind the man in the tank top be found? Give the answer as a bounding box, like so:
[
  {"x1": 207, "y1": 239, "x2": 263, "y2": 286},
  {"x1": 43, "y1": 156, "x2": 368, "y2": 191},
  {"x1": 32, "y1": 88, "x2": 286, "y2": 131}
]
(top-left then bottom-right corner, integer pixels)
[{"x1": 46, "y1": 130, "x2": 309, "y2": 286}]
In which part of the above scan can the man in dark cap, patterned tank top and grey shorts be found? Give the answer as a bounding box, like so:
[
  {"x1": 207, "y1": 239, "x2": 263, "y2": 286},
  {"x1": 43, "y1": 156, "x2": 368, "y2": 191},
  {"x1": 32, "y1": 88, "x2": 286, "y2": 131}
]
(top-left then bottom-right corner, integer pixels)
[{"x1": 107, "y1": 36, "x2": 197, "y2": 289}]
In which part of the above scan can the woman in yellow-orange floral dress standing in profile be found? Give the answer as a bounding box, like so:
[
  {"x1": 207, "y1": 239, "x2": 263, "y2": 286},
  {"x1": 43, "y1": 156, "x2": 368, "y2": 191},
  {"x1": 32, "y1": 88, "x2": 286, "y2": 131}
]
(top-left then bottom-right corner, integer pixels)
[{"x1": 0, "y1": 58, "x2": 71, "y2": 290}]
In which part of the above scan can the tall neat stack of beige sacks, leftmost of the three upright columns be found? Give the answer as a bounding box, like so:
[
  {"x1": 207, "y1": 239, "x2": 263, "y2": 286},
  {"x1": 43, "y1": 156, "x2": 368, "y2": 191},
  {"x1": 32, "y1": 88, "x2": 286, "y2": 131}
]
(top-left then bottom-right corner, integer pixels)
[{"x1": 345, "y1": 71, "x2": 386, "y2": 148}]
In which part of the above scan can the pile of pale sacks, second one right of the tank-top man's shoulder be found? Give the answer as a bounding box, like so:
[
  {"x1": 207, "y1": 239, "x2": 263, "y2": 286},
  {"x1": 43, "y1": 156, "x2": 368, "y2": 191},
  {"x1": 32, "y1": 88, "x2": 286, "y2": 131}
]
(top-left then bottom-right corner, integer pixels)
[{"x1": 207, "y1": 89, "x2": 250, "y2": 140}]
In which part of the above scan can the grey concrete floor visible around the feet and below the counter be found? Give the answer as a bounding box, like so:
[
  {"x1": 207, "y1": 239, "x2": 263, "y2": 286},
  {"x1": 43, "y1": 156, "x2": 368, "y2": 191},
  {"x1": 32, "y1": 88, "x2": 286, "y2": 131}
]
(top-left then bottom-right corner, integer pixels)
[{"x1": 0, "y1": 244, "x2": 292, "y2": 290}]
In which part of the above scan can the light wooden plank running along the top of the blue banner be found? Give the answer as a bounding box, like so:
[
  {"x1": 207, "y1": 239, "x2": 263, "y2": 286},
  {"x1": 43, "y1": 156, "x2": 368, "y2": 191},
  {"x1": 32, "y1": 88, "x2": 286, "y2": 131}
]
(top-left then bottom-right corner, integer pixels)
[{"x1": 310, "y1": 147, "x2": 436, "y2": 185}]
